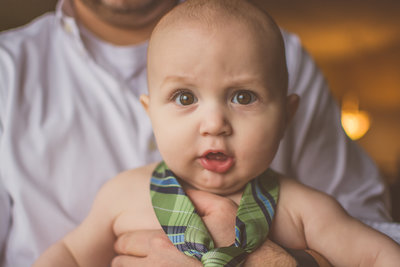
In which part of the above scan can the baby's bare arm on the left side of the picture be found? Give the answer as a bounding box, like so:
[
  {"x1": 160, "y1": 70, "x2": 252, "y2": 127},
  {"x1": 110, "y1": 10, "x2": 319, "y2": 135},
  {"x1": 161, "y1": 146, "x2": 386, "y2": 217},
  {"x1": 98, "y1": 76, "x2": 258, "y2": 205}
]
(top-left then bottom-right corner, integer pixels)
[{"x1": 34, "y1": 169, "x2": 152, "y2": 267}]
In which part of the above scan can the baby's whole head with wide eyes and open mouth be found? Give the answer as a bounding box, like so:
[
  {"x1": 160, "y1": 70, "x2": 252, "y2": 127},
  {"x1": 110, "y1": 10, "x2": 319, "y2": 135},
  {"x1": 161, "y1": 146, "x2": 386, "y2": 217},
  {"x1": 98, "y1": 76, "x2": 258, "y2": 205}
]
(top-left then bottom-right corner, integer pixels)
[{"x1": 141, "y1": 0, "x2": 298, "y2": 194}]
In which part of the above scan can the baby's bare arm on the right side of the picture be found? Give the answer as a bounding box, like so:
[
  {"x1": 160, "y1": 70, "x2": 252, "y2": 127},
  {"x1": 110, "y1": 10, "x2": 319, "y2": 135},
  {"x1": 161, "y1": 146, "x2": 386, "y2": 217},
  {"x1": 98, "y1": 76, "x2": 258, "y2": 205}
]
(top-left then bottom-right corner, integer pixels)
[{"x1": 271, "y1": 179, "x2": 400, "y2": 266}]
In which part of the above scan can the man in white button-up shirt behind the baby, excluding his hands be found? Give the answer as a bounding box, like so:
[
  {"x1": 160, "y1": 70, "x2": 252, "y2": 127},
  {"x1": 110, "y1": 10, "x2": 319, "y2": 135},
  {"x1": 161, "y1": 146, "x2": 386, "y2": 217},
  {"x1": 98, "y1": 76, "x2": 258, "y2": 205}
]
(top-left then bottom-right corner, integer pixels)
[{"x1": 0, "y1": 0, "x2": 390, "y2": 266}]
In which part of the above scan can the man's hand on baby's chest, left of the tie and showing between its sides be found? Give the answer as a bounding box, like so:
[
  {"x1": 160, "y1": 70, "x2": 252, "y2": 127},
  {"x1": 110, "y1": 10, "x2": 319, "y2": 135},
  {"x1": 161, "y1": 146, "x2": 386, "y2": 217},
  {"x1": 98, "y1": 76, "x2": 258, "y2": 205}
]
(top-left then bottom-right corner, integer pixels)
[{"x1": 112, "y1": 190, "x2": 237, "y2": 267}]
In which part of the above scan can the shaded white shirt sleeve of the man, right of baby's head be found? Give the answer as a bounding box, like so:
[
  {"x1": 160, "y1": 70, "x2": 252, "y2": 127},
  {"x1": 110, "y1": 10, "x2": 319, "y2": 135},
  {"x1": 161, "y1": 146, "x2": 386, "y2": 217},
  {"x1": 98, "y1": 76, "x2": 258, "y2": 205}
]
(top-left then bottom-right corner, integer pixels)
[{"x1": 273, "y1": 28, "x2": 391, "y2": 221}]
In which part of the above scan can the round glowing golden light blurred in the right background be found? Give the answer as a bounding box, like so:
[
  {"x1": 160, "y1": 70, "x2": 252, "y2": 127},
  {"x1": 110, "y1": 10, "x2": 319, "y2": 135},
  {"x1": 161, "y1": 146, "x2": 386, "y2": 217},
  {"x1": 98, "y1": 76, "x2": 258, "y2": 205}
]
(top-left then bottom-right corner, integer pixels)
[{"x1": 342, "y1": 95, "x2": 371, "y2": 140}]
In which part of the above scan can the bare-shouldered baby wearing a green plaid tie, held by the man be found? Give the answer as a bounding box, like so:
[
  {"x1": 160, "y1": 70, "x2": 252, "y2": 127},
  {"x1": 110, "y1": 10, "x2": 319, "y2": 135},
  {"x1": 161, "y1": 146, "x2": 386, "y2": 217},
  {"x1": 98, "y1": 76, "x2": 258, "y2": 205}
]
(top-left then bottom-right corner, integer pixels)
[{"x1": 36, "y1": 0, "x2": 400, "y2": 267}]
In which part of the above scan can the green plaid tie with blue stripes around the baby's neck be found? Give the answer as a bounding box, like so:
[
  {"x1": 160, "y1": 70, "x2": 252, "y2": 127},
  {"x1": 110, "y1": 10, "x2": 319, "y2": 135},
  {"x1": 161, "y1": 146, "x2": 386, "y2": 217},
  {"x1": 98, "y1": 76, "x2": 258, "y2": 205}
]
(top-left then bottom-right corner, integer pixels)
[{"x1": 150, "y1": 162, "x2": 279, "y2": 267}]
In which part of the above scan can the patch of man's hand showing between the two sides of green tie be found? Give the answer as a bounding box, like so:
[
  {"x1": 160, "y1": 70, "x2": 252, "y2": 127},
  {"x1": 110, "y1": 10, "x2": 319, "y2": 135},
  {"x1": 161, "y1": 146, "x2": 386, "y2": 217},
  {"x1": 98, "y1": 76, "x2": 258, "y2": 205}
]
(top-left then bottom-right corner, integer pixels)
[{"x1": 186, "y1": 189, "x2": 238, "y2": 247}]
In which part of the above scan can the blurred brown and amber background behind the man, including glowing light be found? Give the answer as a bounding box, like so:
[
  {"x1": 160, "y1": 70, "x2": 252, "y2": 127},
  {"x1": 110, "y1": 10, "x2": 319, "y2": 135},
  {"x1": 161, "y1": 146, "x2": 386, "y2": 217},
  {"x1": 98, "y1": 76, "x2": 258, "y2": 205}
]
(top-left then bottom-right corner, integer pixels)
[{"x1": 0, "y1": 0, "x2": 400, "y2": 221}]
